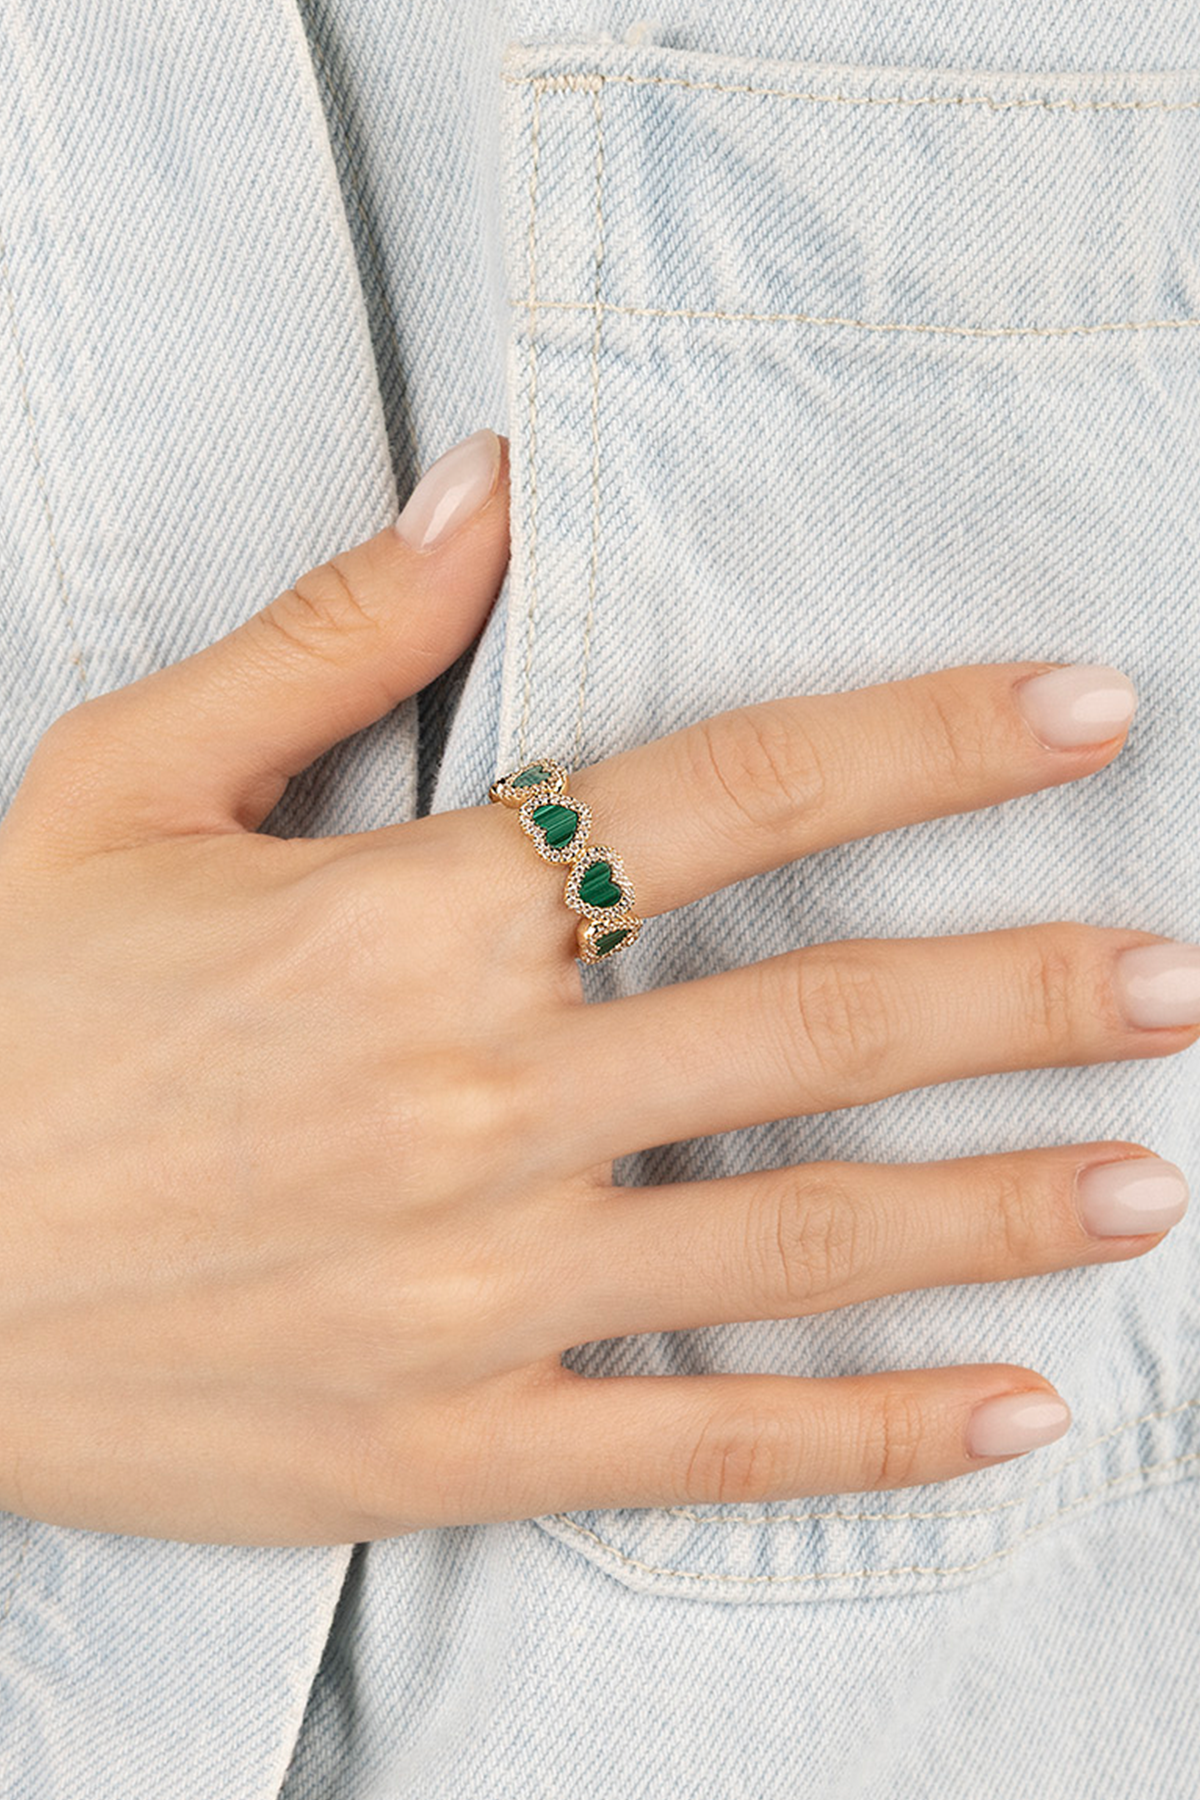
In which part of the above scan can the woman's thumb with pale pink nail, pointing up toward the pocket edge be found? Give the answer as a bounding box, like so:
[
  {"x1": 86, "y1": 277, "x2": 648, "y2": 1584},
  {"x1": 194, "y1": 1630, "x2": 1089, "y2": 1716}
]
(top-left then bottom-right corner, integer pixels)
[{"x1": 7, "y1": 430, "x2": 509, "y2": 853}]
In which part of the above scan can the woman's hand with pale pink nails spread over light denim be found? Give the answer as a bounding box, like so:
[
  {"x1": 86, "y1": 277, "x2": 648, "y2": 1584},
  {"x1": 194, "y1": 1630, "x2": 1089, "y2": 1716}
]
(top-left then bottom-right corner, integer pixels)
[{"x1": 0, "y1": 434, "x2": 1200, "y2": 1544}]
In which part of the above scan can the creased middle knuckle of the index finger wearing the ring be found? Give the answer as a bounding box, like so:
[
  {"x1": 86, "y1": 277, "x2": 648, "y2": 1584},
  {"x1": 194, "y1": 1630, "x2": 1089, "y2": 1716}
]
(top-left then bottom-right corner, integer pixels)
[{"x1": 687, "y1": 702, "x2": 826, "y2": 839}]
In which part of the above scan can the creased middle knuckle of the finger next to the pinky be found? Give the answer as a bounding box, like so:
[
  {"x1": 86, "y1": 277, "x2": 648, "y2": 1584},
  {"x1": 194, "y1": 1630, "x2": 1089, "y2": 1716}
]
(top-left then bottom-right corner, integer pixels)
[{"x1": 748, "y1": 1172, "x2": 871, "y2": 1318}]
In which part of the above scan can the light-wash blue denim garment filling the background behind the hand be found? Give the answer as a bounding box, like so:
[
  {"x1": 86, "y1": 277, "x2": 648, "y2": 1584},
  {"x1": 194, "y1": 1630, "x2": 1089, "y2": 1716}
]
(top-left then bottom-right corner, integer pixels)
[{"x1": 0, "y1": 0, "x2": 1200, "y2": 1800}]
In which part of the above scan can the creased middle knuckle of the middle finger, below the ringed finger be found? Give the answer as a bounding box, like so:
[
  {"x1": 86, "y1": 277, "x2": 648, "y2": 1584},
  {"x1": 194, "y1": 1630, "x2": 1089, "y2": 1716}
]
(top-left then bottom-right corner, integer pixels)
[{"x1": 788, "y1": 943, "x2": 896, "y2": 1091}]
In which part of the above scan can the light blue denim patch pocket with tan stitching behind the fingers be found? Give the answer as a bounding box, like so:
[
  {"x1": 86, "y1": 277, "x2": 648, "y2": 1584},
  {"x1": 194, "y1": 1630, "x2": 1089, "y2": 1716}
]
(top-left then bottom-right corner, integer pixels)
[{"x1": 500, "y1": 31, "x2": 1200, "y2": 1600}]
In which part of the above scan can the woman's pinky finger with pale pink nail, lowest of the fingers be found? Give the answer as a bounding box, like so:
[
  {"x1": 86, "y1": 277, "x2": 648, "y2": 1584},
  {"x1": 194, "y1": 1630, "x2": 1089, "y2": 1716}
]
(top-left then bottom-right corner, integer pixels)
[{"x1": 506, "y1": 1363, "x2": 1070, "y2": 1517}]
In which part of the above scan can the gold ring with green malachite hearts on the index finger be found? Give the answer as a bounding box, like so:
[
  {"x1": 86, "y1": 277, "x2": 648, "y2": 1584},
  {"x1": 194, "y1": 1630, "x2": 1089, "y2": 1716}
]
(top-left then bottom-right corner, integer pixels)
[{"x1": 488, "y1": 756, "x2": 642, "y2": 963}]
